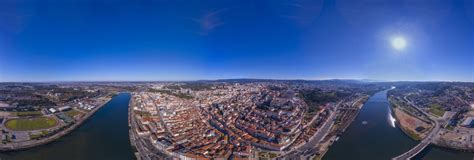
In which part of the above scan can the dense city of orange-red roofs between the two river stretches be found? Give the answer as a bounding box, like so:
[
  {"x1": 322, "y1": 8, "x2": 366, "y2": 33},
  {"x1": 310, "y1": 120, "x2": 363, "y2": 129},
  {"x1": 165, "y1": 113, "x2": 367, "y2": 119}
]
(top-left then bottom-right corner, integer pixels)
[{"x1": 130, "y1": 81, "x2": 382, "y2": 159}]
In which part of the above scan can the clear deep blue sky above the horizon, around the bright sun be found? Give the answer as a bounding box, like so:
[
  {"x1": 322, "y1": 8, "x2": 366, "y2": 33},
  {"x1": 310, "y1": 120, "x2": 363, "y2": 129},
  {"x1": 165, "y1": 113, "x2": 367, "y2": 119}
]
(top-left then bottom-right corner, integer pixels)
[{"x1": 0, "y1": 0, "x2": 474, "y2": 81}]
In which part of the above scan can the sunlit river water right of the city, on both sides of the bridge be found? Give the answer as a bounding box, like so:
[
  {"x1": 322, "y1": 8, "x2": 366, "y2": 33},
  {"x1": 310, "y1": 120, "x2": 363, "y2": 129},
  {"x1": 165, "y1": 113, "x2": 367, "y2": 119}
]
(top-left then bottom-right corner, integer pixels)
[{"x1": 323, "y1": 91, "x2": 474, "y2": 160}]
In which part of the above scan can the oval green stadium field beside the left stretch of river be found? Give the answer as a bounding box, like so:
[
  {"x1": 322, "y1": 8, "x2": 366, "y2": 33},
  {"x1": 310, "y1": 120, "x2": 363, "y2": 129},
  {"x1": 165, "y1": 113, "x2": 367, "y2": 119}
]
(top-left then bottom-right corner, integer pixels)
[{"x1": 5, "y1": 117, "x2": 58, "y2": 131}]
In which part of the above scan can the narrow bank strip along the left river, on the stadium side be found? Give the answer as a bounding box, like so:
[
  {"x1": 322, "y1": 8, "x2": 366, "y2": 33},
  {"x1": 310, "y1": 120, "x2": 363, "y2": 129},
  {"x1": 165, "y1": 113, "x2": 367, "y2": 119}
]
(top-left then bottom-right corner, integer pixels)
[{"x1": 0, "y1": 98, "x2": 112, "y2": 152}]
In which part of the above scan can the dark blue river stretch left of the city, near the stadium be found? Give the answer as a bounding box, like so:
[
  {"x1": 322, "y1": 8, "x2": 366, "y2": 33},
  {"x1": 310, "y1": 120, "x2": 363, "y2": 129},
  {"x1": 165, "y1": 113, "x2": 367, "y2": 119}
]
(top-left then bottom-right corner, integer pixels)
[{"x1": 0, "y1": 93, "x2": 134, "y2": 160}]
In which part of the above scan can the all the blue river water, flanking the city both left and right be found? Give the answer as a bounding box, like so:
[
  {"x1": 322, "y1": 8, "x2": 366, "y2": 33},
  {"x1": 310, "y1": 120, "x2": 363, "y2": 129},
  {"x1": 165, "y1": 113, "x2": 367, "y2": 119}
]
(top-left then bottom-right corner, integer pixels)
[{"x1": 0, "y1": 91, "x2": 474, "y2": 160}]
